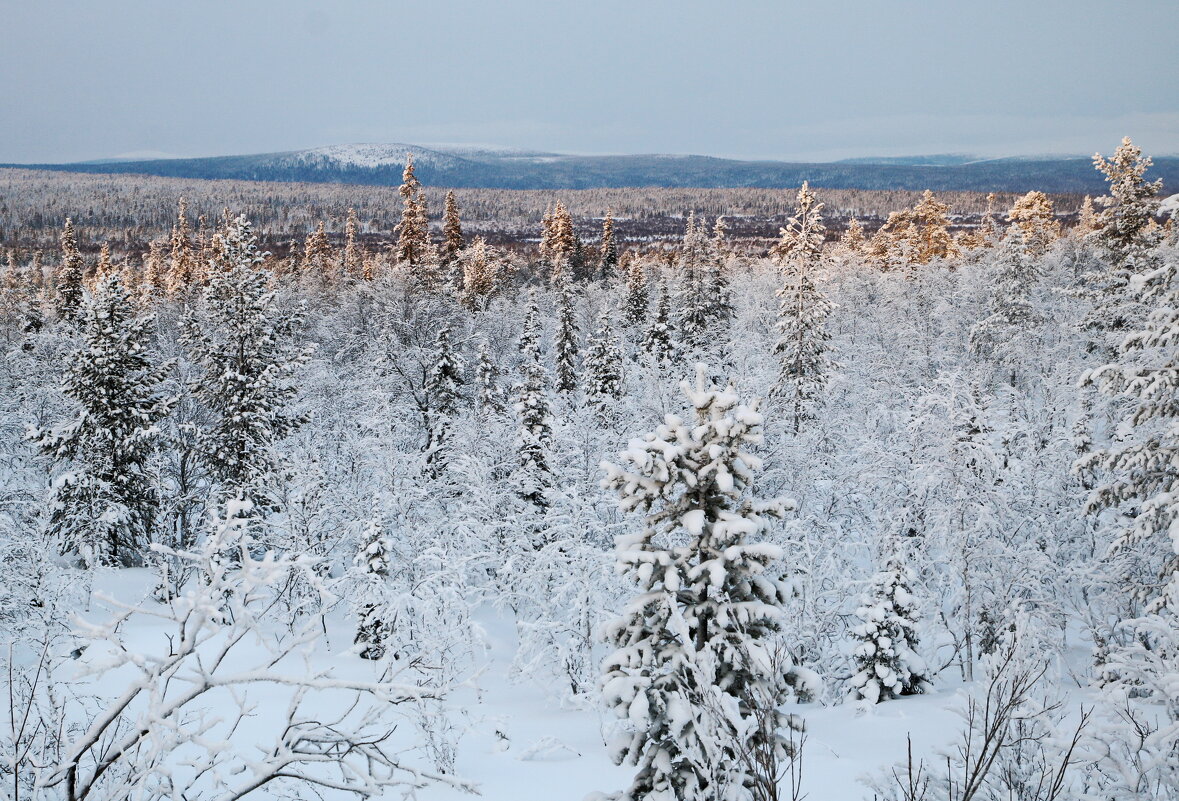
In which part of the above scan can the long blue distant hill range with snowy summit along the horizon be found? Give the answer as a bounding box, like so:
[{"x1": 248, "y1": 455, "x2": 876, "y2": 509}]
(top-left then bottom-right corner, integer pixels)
[{"x1": 0, "y1": 144, "x2": 1179, "y2": 193}]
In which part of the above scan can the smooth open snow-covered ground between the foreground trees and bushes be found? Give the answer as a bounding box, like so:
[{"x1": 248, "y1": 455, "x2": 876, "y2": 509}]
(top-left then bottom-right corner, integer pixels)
[{"x1": 50, "y1": 570, "x2": 1087, "y2": 801}]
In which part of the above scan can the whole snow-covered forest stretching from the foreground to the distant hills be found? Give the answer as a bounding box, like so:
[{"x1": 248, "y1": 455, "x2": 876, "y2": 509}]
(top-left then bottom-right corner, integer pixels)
[{"x1": 0, "y1": 138, "x2": 1179, "y2": 801}]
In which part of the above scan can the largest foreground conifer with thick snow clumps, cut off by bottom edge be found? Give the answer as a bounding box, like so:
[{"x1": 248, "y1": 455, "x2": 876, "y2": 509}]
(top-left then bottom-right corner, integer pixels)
[{"x1": 602, "y1": 365, "x2": 796, "y2": 801}]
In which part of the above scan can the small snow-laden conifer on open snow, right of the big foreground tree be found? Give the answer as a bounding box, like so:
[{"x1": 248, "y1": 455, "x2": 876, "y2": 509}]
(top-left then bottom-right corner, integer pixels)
[{"x1": 851, "y1": 547, "x2": 929, "y2": 703}]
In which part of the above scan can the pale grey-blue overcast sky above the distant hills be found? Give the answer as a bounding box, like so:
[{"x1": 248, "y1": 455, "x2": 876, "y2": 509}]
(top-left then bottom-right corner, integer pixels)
[{"x1": 0, "y1": 0, "x2": 1179, "y2": 162}]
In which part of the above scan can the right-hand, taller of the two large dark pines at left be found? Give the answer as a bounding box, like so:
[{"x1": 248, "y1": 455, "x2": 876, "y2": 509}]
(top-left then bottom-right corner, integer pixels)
[{"x1": 184, "y1": 216, "x2": 305, "y2": 512}]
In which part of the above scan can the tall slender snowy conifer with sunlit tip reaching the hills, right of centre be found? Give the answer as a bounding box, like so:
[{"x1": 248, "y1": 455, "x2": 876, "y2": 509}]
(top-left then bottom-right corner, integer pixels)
[{"x1": 772, "y1": 183, "x2": 834, "y2": 434}]
